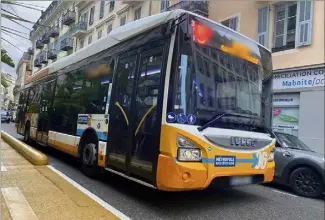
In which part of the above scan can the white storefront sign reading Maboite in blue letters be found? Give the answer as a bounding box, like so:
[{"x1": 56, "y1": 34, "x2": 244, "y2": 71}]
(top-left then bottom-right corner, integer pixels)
[{"x1": 273, "y1": 67, "x2": 325, "y2": 90}]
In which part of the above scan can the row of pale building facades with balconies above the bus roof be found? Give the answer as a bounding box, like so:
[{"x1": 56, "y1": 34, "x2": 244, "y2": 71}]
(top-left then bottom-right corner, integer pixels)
[{"x1": 28, "y1": 0, "x2": 208, "y2": 76}]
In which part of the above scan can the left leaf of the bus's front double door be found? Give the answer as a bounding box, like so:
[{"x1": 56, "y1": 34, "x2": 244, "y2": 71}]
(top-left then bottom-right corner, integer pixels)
[{"x1": 107, "y1": 52, "x2": 138, "y2": 171}]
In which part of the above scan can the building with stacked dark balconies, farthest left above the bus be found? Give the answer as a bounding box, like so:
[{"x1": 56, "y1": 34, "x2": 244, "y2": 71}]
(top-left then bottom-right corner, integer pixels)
[{"x1": 28, "y1": 1, "x2": 76, "y2": 74}]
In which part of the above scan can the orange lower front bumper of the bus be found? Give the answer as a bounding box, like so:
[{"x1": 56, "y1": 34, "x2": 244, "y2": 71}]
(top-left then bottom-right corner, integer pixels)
[{"x1": 157, "y1": 155, "x2": 275, "y2": 191}]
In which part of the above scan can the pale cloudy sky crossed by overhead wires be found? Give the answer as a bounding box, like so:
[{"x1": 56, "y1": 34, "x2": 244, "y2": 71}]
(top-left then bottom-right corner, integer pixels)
[{"x1": 1, "y1": 1, "x2": 52, "y2": 76}]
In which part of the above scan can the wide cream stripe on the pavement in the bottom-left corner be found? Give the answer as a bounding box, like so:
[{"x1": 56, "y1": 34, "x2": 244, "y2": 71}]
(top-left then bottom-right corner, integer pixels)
[{"x1": 1, "y1": 187, "x2": 38, "y2": 220}]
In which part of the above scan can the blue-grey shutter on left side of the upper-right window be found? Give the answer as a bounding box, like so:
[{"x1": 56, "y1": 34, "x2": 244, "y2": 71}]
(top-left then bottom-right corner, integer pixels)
[{"x1": 257, "y1": 6, "x2": 270, "y2": 47}]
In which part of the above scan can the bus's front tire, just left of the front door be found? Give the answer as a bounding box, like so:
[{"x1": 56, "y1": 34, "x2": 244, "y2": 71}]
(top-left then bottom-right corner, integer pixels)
[{"x1": 80, "y1": 142, "x2": 100, "y2": 178}]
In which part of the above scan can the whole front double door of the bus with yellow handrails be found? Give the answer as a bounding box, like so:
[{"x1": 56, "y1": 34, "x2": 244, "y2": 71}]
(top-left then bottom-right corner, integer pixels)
[{"x1": 107, "y1": 42, "x2": 165, "y2": 181}]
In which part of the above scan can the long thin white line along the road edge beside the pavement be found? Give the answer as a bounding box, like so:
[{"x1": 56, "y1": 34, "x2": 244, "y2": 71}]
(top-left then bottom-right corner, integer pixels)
[{"x1": 47, "y1": 165, "x2": 131, "y2": 220}]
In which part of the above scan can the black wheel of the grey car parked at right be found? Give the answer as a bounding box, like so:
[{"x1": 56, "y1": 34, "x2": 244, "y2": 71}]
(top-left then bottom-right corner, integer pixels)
[{"x1": 289, "y1": 167, "x2": 324, "y2": 198}]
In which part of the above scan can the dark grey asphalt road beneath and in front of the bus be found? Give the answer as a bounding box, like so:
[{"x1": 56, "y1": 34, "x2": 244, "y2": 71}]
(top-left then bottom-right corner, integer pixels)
[{"x1": 2, "y1": 124, "x2": 324, "y2": 220}]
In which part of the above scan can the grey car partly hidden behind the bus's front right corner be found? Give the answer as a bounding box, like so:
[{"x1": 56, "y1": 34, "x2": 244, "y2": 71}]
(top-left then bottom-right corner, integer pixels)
[{"x1": 274, "y1": 132, "x2": 325, "y2": 197}]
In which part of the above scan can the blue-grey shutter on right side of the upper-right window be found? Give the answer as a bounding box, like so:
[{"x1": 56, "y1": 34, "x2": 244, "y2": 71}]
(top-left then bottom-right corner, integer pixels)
[{"x1": 296, "y1": 1, "x2": 313, "y2": 47}]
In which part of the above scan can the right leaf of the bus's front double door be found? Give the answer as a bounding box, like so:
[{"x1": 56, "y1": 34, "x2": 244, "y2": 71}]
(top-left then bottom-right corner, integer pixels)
[{"x1": 129, "y1": 44, "x2": 164, "y2": 181}]
